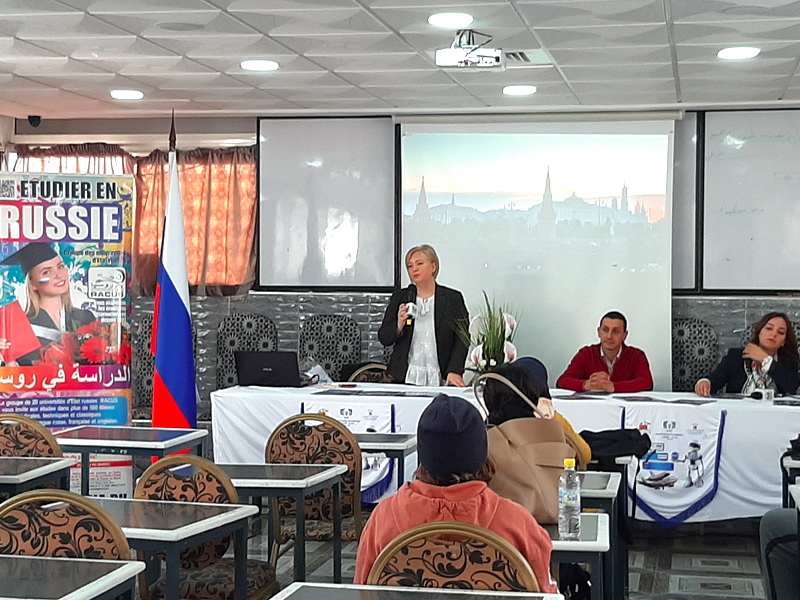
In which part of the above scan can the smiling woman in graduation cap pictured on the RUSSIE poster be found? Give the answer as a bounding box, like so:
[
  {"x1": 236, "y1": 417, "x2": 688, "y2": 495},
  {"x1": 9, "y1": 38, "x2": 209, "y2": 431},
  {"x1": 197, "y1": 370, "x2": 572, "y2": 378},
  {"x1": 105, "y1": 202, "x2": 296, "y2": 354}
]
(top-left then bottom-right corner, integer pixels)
[{"x1": 0, "y1": 242, "x2": 96, "y2": 365}]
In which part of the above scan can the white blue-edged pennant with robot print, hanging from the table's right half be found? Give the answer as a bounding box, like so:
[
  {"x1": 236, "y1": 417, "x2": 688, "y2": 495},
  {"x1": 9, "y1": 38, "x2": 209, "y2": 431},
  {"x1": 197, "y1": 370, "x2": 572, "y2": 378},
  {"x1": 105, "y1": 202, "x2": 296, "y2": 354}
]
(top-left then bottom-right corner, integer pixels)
[{"x1": 623, "y1": 404, "x2": 726, "y2": 527}]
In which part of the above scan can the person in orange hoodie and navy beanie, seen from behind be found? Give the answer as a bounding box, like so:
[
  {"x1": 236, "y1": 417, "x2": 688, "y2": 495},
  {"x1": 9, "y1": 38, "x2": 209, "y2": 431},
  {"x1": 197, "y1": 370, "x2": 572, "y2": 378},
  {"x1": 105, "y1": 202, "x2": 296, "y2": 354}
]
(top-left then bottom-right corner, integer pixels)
[{"x1": 355, "y1": 394, "x2": 556, "y2": 592}]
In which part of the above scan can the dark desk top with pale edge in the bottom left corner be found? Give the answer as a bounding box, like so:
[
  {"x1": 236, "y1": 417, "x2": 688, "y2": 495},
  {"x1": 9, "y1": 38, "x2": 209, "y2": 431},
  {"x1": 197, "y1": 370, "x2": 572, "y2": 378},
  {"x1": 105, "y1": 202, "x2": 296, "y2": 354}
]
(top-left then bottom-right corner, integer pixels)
[{"x1": 0, "y1": 555, "x2": 145, "y2": 600}]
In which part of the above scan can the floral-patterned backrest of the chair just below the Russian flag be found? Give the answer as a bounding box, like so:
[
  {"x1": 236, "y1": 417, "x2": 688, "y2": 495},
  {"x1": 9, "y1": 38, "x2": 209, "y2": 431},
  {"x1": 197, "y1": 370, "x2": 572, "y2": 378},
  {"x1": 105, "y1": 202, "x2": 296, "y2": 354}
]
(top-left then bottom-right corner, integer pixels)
[{"x1": 133, "y1": 454, "x2": 239, "y2": 569}]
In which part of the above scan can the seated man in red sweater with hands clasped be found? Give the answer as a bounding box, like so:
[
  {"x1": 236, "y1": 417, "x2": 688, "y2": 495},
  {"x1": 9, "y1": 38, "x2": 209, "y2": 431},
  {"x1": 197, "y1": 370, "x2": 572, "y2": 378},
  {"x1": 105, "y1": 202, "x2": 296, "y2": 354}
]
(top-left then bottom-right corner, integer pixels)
[{"x1": 556, "y1": 310, "x2": 653, "y2": 392}]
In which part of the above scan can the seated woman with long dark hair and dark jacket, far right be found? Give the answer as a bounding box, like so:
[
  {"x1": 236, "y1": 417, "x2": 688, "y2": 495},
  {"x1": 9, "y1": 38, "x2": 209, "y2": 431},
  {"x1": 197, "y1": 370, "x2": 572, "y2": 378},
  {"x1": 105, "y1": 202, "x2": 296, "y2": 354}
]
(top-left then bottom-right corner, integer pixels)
[{"x1": 694, "y1": 312, "x2": 800, "y2": 396}]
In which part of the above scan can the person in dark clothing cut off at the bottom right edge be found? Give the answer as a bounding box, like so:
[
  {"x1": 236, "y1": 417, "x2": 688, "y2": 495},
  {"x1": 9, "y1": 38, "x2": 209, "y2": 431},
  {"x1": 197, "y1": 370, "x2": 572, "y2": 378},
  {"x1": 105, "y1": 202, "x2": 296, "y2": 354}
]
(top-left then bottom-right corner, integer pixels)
[{"x1": 759, "y1": 508, "x2": 800, "y2": 600}]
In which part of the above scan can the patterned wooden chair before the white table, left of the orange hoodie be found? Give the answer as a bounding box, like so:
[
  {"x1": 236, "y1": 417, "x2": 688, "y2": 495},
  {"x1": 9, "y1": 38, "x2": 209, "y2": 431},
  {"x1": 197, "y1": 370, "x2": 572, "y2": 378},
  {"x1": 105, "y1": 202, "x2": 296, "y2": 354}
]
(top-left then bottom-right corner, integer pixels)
[{"x1": 265, "y1": 414, "x2": 363, "y2": 545}]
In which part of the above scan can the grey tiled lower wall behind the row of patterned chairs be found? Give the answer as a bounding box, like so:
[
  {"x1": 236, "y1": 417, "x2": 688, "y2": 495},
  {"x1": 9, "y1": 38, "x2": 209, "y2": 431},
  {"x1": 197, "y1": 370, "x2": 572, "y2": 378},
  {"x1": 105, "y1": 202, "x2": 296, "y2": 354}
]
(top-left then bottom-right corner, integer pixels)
[{"x1": 133, "y1": 292, "x2": 800, "y2": 417}]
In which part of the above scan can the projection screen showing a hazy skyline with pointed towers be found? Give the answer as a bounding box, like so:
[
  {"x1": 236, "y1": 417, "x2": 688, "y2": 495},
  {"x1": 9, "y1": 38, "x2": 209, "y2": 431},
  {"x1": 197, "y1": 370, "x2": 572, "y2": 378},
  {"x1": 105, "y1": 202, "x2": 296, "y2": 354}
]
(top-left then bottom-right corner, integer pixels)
[{"x1": 402, "y1": 120, "x2": 674, "y2": 390}]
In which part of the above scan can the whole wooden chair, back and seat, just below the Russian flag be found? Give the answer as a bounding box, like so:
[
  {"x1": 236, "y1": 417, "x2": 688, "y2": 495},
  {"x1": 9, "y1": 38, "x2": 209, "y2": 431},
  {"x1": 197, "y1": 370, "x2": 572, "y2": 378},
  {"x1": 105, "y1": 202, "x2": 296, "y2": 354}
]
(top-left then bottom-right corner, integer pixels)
[{"x1": 133, "y1": 454, "x2": 279, "y2": 600}]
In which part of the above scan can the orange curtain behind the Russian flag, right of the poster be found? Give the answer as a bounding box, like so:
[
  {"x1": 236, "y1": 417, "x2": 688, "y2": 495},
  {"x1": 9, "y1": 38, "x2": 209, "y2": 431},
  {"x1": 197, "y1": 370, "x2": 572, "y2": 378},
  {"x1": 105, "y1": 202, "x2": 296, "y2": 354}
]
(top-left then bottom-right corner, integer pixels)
[{"x1": 132, "y1": 146, "x2": 257, "y2": 296}]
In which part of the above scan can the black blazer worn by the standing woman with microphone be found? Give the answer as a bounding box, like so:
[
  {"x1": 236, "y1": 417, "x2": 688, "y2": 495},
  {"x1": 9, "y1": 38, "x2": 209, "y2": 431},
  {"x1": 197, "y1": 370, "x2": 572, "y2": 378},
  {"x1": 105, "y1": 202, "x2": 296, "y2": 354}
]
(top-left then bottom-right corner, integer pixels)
[{"x1": 378, "y1": 283, "x2": 469, "y2": 382}]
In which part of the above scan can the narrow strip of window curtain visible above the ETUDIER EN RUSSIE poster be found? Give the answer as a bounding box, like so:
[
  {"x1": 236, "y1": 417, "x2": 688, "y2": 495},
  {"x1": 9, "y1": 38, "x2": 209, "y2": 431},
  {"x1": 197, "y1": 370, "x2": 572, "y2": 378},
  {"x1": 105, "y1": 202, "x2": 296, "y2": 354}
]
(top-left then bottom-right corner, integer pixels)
[{"x1": 8, "y1": 143, "x2": 134, "y2": 175}]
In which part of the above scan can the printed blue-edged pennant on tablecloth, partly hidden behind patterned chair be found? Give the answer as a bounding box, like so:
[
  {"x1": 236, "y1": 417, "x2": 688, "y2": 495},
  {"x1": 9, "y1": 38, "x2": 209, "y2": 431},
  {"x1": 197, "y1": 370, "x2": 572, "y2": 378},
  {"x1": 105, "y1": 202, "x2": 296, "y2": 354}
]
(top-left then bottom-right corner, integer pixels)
[{"x1": 301, "y1": 398, "x2": 394, "y2": 504}]
